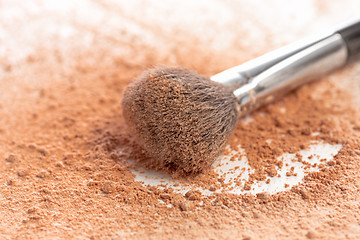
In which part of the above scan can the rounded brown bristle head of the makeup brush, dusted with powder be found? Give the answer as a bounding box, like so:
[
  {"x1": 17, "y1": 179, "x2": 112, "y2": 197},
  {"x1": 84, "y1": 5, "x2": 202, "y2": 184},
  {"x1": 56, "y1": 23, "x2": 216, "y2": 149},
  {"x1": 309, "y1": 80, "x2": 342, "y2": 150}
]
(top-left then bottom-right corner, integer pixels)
[{"x1": 122, "y1": 67, "x2": 238, "y2": 173}]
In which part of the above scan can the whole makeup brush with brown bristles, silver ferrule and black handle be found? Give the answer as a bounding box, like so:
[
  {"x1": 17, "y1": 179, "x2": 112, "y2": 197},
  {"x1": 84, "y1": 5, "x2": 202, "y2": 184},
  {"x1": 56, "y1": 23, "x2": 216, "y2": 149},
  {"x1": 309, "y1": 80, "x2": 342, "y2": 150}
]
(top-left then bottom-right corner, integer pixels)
[{"x1": 122, "y1": 20, "x2": 360, "y2": 173}]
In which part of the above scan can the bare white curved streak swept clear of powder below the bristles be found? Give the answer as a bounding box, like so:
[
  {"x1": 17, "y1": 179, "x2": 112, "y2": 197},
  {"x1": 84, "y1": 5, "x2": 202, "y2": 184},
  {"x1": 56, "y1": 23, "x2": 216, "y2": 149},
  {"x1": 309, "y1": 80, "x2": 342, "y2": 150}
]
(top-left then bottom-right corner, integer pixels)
[{"x1": 132, "y1": 142, "x2": 342, "y2": 195}]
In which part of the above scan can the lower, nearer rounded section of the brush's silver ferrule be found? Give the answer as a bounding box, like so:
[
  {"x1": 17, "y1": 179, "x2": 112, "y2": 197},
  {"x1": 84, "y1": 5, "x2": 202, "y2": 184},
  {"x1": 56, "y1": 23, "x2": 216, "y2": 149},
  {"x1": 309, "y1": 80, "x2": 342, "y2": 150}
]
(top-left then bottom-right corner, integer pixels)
[{"x1": 234, "y1": 33, "x2": 349, "y2": 115}]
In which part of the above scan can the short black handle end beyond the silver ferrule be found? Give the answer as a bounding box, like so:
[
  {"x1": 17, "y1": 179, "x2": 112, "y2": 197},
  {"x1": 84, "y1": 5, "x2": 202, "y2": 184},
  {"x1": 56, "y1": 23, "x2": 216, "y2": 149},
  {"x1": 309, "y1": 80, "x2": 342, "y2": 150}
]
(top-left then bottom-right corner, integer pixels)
[{"x1": 337, "y1": 19, "x2": 360, "y2": 61}]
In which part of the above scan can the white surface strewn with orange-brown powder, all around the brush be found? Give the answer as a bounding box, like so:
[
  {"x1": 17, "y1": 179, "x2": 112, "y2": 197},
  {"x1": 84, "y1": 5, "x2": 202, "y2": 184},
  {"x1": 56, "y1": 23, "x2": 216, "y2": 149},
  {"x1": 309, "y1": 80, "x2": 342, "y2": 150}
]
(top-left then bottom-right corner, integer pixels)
[{"x1": 0, "y1": 0, "x2": 360, "y2": 239}]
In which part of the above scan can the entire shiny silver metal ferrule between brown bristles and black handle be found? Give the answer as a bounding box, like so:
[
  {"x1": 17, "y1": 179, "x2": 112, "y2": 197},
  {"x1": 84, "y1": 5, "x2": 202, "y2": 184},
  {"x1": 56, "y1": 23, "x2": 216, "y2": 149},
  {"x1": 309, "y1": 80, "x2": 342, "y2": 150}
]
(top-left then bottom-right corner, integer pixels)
[{"x1": 211, "y1": 33, "x2": 348, "y2": 115}]
